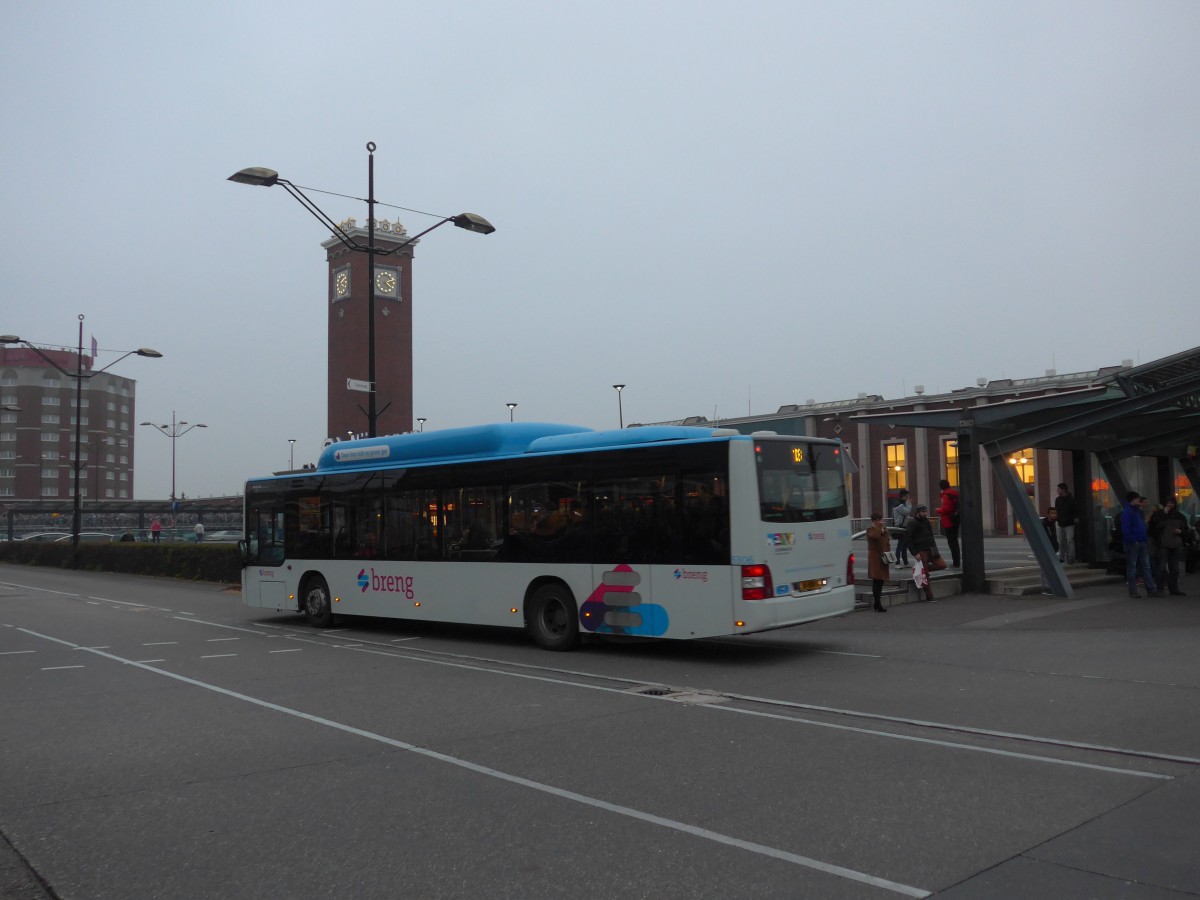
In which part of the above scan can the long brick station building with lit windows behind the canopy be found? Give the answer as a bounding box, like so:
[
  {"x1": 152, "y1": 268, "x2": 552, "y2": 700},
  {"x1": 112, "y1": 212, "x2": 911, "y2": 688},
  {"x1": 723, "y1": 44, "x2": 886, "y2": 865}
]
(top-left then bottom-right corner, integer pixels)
[{"x1": 655, "y1": 349, "x2": 1200, "y2": 557}]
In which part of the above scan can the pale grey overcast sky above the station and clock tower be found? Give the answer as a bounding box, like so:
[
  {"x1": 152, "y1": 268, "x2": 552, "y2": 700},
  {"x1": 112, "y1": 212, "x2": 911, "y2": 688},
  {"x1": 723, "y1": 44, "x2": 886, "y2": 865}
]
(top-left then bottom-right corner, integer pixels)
[{"x1": 0, "y1": 0, "x2": 1200, "y2": 498}]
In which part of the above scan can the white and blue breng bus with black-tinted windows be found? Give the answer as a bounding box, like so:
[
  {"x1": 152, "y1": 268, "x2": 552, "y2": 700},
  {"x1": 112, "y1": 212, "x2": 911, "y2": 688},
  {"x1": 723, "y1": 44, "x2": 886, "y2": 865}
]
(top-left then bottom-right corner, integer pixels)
[{"x1": 241, "y1": 422, "x2": 854, "y2": 650}]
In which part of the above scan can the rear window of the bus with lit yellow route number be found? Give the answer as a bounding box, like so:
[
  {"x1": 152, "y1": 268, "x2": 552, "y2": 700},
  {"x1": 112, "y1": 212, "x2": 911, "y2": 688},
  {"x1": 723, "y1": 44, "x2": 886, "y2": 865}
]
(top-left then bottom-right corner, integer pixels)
[{"x1": 755, "y1": 440, "x2": 848, "y2": 522}]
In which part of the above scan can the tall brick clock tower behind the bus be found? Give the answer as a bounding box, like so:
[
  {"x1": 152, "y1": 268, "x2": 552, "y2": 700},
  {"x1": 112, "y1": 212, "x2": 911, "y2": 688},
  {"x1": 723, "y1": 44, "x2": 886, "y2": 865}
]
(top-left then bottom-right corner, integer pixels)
[{"x1": 320, "y1": 218, "x2": 416, "y2": 440}]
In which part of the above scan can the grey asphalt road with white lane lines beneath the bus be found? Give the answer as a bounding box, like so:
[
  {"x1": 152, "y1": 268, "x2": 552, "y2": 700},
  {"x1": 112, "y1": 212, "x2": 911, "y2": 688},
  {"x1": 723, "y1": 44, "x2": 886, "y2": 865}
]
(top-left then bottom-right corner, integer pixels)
[{"x1": 0, "y1": 565, "x2": 1200, "y2": 900}]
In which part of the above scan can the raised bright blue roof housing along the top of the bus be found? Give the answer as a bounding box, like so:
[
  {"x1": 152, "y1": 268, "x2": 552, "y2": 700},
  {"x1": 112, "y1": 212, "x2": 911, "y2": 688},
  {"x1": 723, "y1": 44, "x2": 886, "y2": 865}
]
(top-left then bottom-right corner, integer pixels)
[{"x1": 317, "y1": 422, "x2": 734, "y2": 472}]
